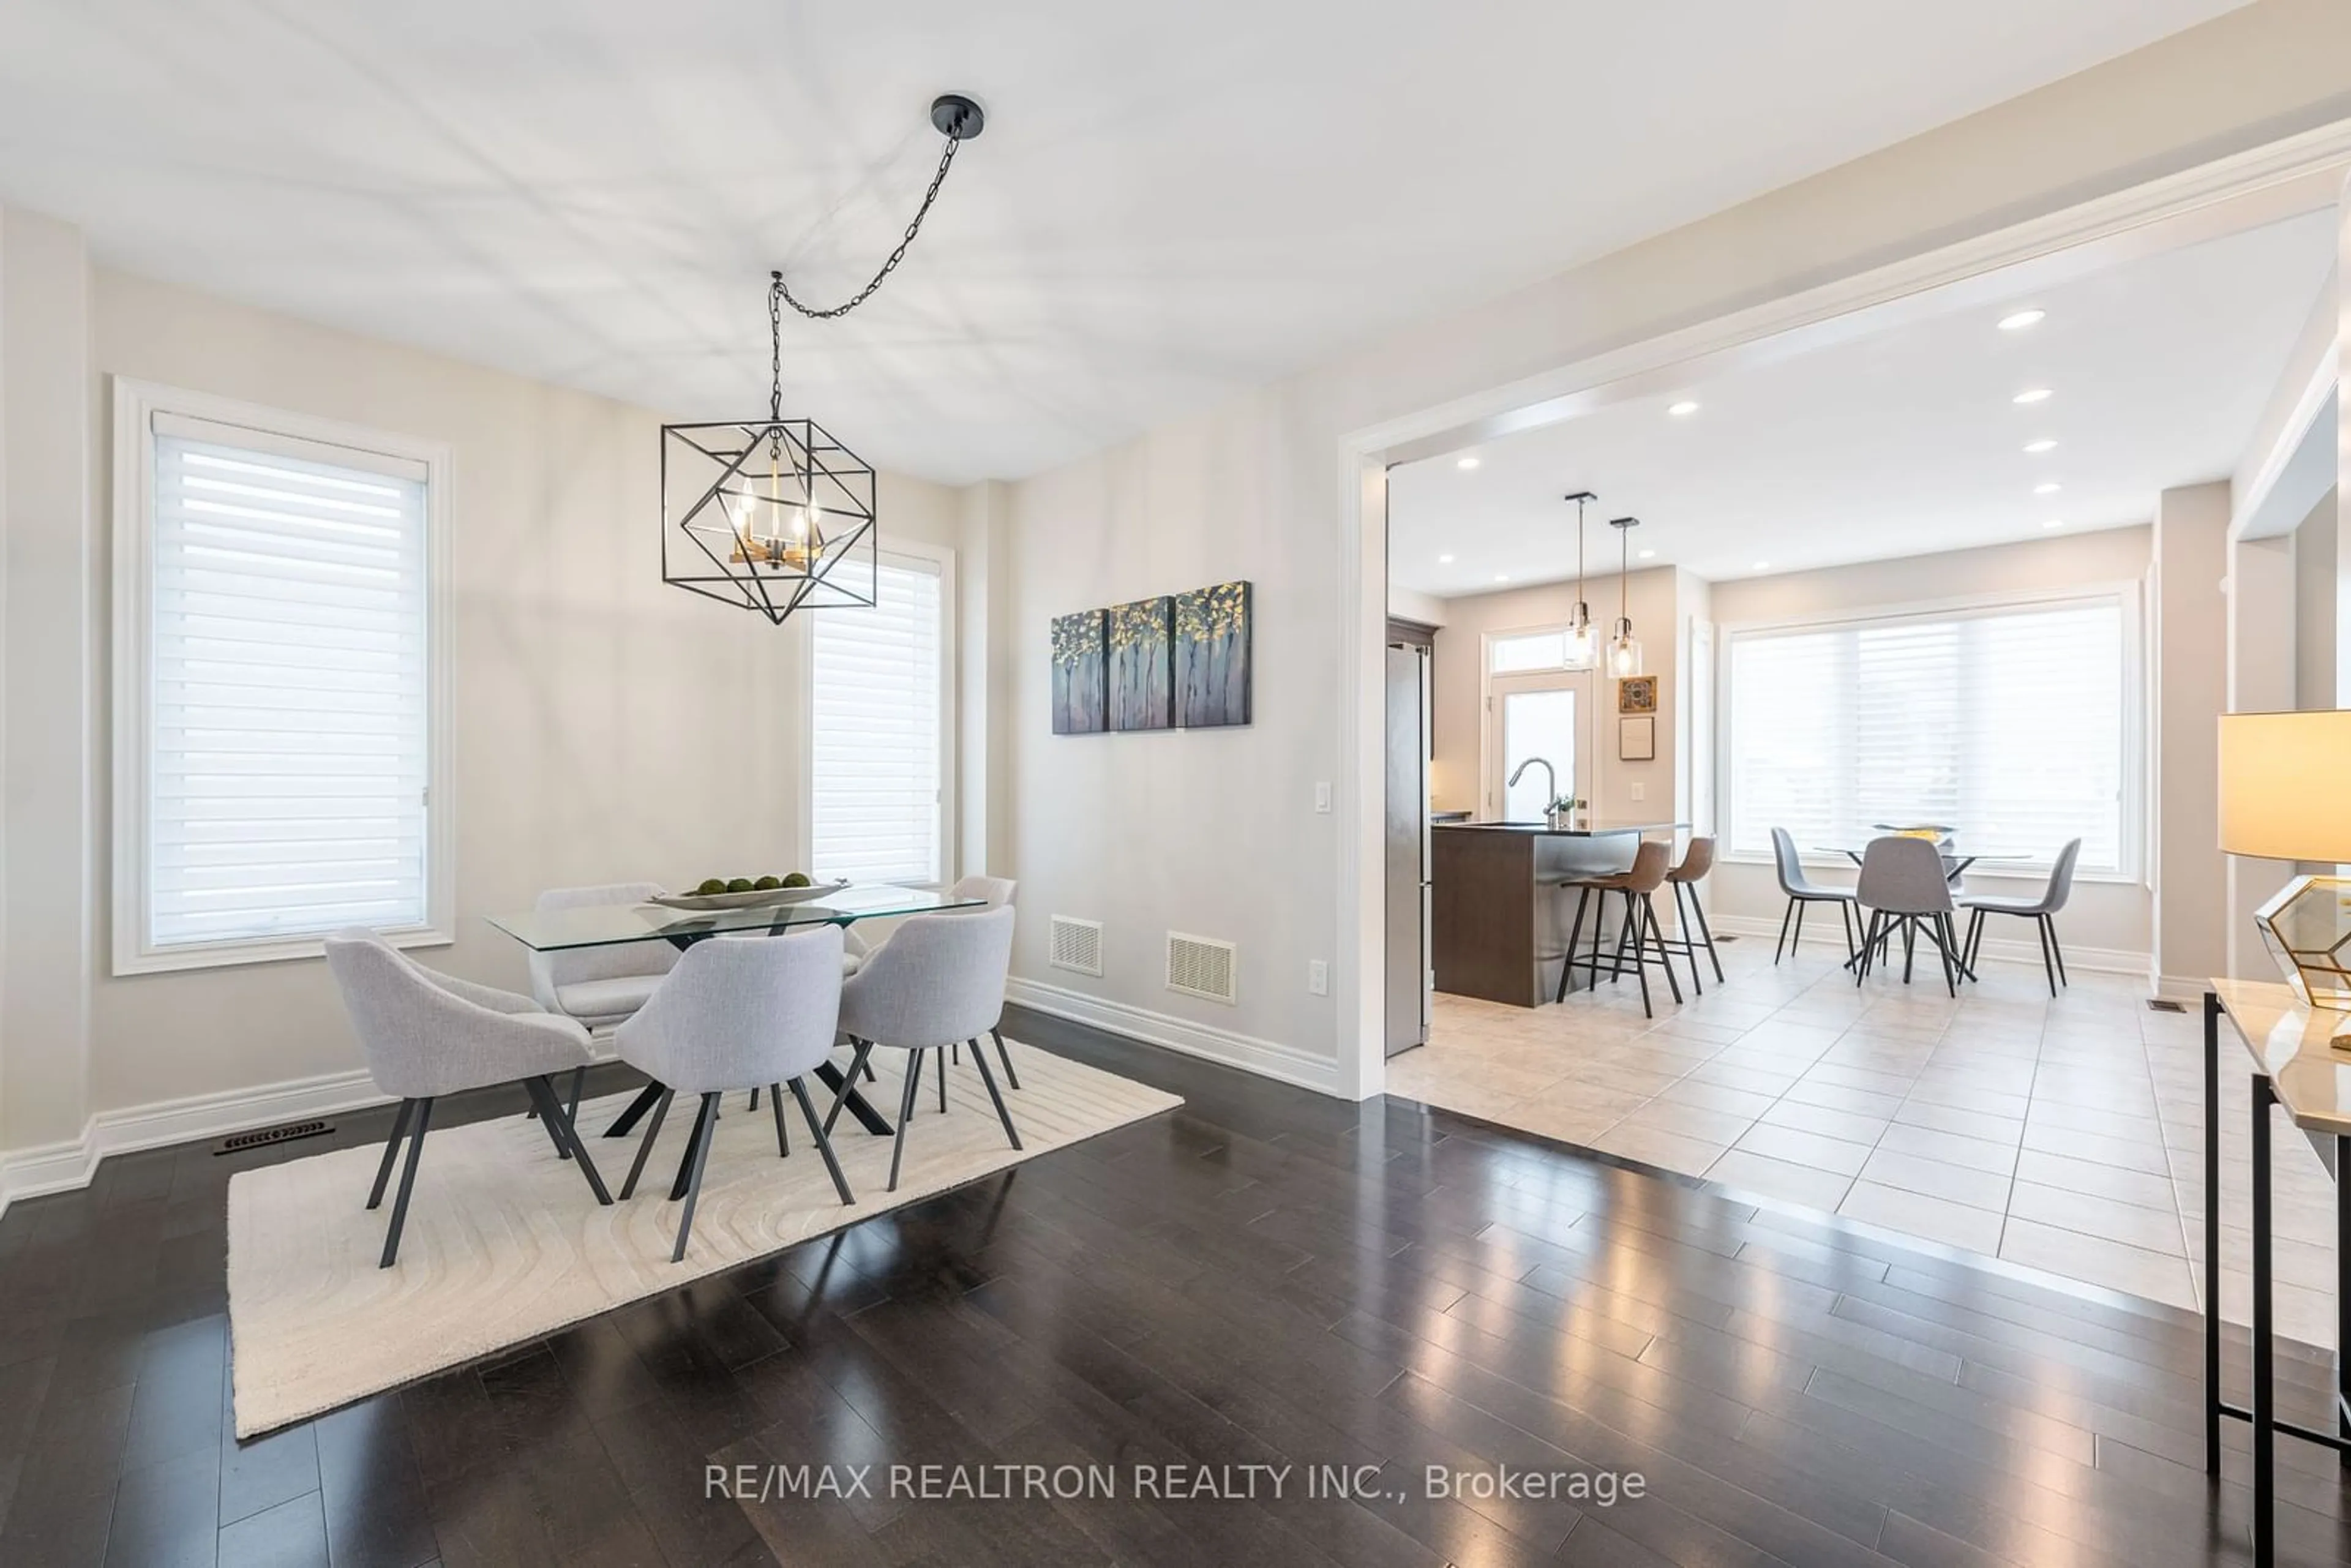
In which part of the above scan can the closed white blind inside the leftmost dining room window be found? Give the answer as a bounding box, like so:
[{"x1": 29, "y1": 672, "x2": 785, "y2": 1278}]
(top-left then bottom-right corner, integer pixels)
[{"x1": 146, "y1": 414, "x2": 430, "y2": 950}]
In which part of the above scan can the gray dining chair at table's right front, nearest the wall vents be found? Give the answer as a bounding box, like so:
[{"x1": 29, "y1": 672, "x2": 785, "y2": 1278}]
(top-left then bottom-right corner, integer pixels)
[{"x1": 825, "y1": 907, "x2": 1021, "y2": 1192}]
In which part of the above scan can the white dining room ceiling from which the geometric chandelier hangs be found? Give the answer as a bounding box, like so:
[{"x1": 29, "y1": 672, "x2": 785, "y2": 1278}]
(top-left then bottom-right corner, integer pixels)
[{"x1": 0, "y1": 0, "x2": 2241, "y2": 479}]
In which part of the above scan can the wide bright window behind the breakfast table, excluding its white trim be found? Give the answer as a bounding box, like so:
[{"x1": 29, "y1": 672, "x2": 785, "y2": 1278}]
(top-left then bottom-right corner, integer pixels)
[{"x1": 1723, "y1": 593, "x2": 2139, "y2": 872}]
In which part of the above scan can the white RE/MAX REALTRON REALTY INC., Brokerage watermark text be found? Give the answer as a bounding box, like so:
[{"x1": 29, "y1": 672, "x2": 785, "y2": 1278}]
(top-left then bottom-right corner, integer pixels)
[{"x1": 703, "y1": 1465, "x2": 1648, "y2": 1507}]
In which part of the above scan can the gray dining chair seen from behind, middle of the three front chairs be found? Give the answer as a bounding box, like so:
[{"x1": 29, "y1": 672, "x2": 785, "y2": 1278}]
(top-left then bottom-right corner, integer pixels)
[{"x1": 613, "y1": 926, "x2": 856, "y2": 1262}]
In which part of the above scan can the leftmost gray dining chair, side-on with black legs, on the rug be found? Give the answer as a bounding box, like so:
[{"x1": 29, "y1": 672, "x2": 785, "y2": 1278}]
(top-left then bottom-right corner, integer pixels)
[{"x1": 327, "y1": 929, "x2": 611, "y2": 1269}]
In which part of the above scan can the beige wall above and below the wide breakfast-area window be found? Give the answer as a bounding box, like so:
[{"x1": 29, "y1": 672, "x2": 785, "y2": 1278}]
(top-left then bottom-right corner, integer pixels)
[{"x1": 1709, "y1": 527, "x2": 2153, "y2": 971}]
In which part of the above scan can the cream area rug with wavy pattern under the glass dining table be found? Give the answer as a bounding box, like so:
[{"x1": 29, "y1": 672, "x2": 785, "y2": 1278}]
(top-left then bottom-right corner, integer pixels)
[{"x1": 228, "y1": 1041, "x2": 1183, "y2": 1436}]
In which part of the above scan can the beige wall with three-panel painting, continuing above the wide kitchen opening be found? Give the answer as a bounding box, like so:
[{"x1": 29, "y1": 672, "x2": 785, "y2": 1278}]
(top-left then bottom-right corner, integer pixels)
[{"x1": 1011, "y1": 0, "x2": 2351, "y2": 1093}]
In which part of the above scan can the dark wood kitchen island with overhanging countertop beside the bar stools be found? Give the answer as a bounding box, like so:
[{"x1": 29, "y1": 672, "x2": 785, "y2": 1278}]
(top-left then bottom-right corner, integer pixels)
[{"x1": 1430, "y1": 823, "x2": 1688, "y2": 1006}]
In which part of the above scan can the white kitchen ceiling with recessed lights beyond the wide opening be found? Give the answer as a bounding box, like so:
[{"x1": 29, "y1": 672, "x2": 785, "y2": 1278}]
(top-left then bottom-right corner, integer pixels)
[{"x1": 1389, "y1": 209, "x2": 2334, "y2": 597}]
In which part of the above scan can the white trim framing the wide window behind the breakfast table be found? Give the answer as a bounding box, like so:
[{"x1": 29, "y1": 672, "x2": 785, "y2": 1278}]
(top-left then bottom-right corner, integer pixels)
[{"x1": 1714, "y1": 579, "x2": 2153, "y2": 887}]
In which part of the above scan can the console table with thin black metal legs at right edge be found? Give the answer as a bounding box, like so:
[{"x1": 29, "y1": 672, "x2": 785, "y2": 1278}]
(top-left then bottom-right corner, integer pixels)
[{"x1": 2203, "y1": 980, "x2": 2351, "y2": 1568}]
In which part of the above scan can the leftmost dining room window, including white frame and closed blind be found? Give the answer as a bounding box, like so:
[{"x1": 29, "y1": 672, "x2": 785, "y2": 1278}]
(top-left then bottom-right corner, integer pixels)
[{"x1": 115, "y1": 383, "x2": 451, "y2": 973}]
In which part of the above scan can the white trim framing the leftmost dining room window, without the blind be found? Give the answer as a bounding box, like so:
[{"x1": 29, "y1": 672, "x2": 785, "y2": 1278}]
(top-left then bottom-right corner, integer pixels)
[{"x1": 108, "y1": 376, "x2": 456, "y2": 975}]
